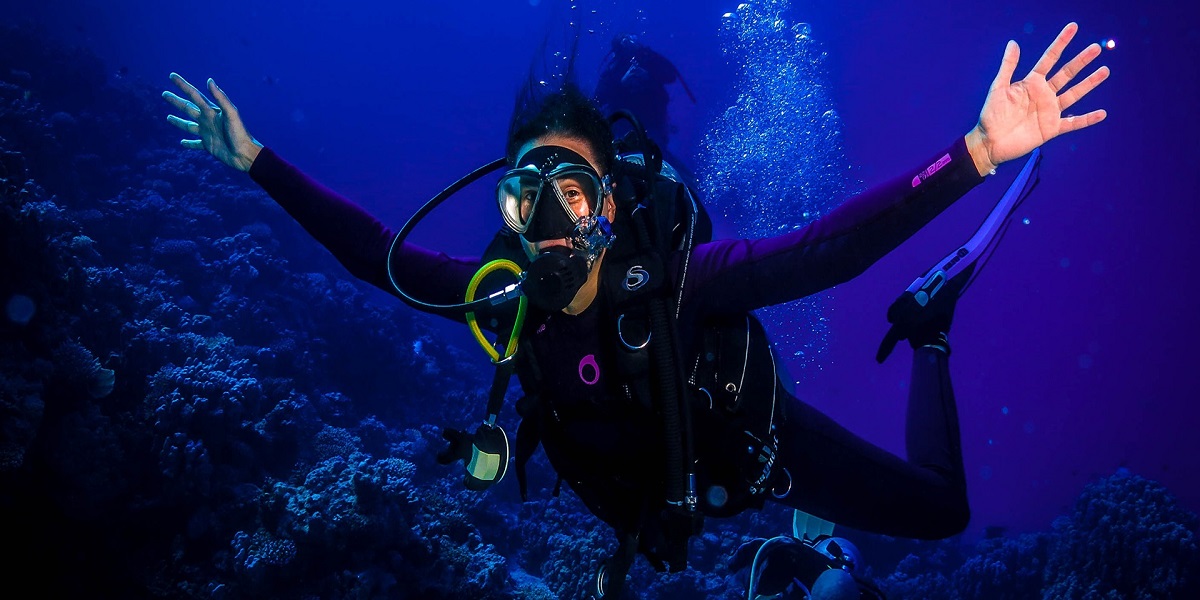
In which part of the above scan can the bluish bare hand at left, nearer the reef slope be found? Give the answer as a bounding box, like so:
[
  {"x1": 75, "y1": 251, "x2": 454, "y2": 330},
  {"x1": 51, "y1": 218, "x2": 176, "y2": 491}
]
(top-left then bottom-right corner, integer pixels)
[{"x1": 162, "y1": 73, "x2": 263, "y2": 170}]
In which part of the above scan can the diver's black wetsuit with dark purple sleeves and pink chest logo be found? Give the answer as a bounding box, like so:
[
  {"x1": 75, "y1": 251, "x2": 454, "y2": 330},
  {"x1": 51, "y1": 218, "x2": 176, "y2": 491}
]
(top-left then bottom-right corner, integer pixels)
[{"x1": 250, "y1": 140, "x2": 983, "y2": 539}]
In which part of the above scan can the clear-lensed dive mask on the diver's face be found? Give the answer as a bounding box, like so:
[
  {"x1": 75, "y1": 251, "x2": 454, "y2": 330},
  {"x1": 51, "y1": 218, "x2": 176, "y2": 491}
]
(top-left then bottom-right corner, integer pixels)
[{"x1": 496, "y1": 145, "x2": 610, "y2": 242}]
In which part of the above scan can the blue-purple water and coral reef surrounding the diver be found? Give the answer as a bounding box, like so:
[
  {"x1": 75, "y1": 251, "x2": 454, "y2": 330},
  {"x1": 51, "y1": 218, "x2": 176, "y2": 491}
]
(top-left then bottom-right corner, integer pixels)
[{"x1": 0, "y1": 0, "x2": 1200, "y2": 599}]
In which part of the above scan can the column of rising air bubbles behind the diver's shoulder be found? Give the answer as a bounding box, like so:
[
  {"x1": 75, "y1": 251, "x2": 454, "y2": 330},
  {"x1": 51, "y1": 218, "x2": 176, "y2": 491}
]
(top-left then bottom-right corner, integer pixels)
[{"x1": 697, "y1": 0, "x2": 844, "y2": 371}]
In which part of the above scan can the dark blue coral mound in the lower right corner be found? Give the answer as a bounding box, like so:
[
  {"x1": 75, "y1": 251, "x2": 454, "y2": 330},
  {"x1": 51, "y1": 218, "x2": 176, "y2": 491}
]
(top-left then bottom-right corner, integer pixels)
[{"x1": 880, "y1": 469, "x2": 1200, "y2": 600}]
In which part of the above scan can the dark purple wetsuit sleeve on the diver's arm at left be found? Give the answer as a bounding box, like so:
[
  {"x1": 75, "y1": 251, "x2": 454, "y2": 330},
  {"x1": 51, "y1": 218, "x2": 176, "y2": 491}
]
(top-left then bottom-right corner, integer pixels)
[{"x1": 250, "y1": 148, "x2": 479, "y2": 312}]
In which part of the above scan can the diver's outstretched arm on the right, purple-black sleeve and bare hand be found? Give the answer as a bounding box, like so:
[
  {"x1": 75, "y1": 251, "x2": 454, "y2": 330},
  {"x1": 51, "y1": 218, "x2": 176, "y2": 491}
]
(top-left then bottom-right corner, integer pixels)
[{"x1": 680, "y1": 23, "x2": 1109, "y2": 312}]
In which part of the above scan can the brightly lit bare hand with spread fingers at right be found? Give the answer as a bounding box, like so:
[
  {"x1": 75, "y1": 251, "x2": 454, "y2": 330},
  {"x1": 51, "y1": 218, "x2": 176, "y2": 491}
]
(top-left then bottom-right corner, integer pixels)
[{"x1": 967, "y1": 23, "x2": 1109, "y2": 174}]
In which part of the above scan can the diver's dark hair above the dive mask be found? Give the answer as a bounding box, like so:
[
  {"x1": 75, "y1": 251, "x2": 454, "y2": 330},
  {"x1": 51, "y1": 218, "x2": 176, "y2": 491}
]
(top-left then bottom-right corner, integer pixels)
[{"x1": 504, "y1": 78, "x2": 616, "y2": 173}]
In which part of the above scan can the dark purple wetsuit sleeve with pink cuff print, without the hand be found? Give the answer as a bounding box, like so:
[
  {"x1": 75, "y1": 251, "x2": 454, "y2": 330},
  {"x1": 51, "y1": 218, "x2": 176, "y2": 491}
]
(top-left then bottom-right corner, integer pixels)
[{"x1": 677, "y1": 139, "x2": 983, "y2": 314}]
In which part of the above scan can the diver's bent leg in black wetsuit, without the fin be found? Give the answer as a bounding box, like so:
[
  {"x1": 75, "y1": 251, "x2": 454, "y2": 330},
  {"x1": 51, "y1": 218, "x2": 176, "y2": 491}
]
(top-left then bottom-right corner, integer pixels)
[{"x1": 779, "y1": 347, "x2": 970, "y2": 539}]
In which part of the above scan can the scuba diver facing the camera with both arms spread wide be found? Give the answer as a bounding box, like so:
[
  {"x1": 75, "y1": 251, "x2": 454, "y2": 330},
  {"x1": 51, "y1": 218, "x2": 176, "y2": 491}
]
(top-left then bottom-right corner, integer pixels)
[{"x1": 163, "y1": 23, "x2": 1109, "y2": 599}]
